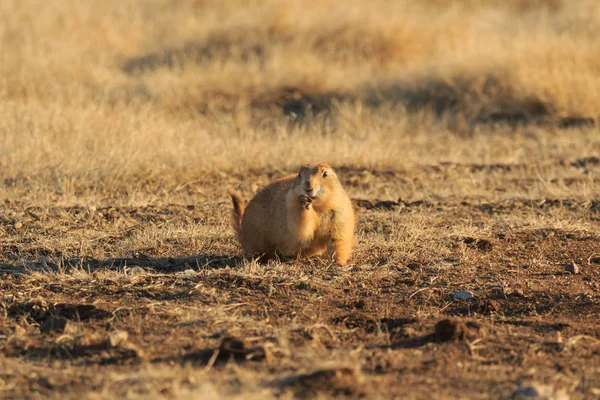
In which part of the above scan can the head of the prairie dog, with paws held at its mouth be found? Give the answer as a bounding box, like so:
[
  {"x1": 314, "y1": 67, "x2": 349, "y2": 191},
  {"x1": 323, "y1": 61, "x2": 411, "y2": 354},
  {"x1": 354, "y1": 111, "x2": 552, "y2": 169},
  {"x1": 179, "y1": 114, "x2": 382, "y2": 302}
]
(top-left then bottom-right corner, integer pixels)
[{"x1": 294, "y1": 162, "x2": 340, "y2": 200}]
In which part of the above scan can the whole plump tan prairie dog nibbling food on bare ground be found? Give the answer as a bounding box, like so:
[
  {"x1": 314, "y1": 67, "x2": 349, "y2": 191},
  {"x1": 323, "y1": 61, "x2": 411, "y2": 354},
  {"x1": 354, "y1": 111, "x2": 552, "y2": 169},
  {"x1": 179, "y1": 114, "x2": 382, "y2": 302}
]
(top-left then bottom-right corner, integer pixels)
[{"x1": 230, "y1": 163, "x2": 355, "y2": 265}]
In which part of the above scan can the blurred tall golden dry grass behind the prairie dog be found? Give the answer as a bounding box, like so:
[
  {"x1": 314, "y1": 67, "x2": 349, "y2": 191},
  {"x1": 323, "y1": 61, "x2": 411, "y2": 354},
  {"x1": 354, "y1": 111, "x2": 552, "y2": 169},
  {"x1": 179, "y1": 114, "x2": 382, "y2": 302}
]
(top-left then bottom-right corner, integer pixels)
[{"x1": 0, "y1": 0, "x2": 600, "y2": 203}]
